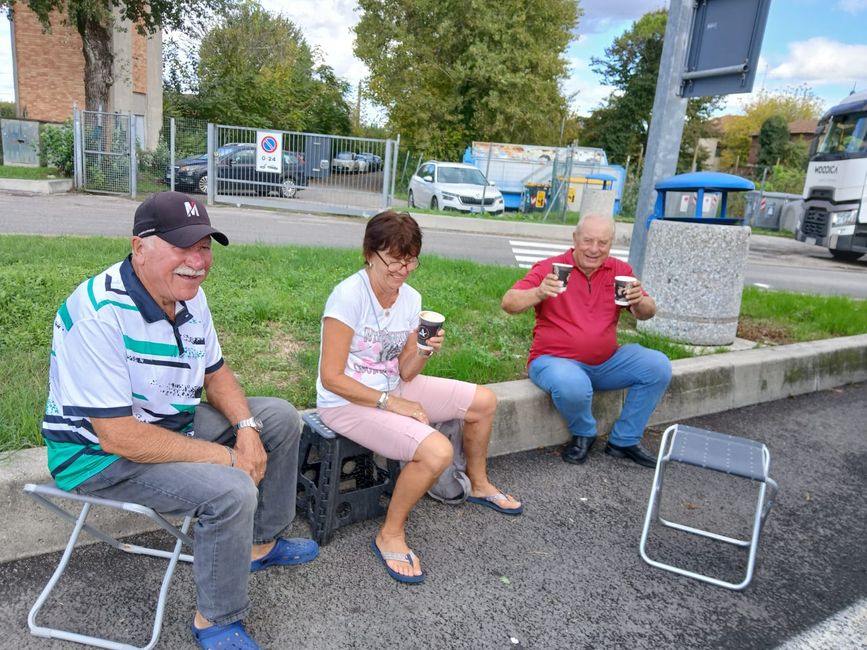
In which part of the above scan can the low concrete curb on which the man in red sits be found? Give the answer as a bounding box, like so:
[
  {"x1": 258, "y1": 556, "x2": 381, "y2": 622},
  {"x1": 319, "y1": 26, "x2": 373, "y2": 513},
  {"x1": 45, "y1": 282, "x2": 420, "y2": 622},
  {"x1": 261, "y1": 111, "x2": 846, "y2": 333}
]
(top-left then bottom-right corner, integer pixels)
[{"x1": 0, "y1": 334, "x2": 867, "y2": 562}]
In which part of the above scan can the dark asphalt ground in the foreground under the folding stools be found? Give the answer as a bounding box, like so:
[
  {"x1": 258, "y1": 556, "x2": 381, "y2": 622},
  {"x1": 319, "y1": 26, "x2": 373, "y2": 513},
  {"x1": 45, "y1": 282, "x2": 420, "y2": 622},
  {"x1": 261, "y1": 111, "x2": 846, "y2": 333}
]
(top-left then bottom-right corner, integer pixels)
[{"x1": 0, "y1": 384, "x2": 867, "y2": 650}]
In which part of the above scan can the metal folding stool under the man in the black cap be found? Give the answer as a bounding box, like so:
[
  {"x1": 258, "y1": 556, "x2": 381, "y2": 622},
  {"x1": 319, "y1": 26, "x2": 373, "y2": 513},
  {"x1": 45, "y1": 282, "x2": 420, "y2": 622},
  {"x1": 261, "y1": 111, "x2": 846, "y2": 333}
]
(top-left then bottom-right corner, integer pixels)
[{"x1": 24, "y1": 483, "x2": 193, "y2": 650}]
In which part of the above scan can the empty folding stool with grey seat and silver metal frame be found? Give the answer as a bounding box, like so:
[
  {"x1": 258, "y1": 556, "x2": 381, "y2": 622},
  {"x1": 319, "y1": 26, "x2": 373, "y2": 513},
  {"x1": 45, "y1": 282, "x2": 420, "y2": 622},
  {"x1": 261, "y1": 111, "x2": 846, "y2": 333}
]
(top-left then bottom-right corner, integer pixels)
[{"x1": 640, "y1": 424, "x2": 778, "y2": 590}]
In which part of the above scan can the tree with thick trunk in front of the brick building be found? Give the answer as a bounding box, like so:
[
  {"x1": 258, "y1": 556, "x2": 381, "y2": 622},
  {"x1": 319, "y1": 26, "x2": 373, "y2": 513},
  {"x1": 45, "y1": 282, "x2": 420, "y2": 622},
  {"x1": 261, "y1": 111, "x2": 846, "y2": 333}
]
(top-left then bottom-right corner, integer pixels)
[{"x1": 0, "y1": 0, "x2": 231, "y2": 110}]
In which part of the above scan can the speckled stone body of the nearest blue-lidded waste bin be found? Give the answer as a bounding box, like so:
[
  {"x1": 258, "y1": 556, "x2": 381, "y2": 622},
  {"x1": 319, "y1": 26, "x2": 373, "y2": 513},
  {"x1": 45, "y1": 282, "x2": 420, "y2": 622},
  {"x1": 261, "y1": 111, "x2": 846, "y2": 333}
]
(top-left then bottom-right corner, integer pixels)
[{"x1": 638, "y1": 219, "x2": 750, "y2": 346}]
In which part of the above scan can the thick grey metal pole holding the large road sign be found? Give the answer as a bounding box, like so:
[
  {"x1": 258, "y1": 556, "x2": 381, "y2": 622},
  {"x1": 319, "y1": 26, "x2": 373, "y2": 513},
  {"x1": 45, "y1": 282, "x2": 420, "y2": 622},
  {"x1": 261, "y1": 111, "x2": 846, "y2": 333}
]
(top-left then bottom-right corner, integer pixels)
[{"x1": 629, "y1": 0, "x2": 693, "y2": 277}]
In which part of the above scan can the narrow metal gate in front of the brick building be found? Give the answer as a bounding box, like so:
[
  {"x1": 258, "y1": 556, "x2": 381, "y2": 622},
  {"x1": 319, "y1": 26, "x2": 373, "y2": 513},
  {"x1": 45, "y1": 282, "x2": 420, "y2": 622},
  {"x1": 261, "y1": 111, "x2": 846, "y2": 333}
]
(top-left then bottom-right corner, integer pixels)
[{"x1": 73, "y1": 109, "x2": 136, "y2": 196}]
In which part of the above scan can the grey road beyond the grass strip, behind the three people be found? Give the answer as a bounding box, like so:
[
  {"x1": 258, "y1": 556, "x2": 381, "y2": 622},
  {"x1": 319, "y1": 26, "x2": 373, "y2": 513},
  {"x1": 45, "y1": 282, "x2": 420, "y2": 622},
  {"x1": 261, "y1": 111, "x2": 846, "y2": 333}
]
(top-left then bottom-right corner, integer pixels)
[{"x1": 0, "y1": 192, "x2": 867, "y2": 298}]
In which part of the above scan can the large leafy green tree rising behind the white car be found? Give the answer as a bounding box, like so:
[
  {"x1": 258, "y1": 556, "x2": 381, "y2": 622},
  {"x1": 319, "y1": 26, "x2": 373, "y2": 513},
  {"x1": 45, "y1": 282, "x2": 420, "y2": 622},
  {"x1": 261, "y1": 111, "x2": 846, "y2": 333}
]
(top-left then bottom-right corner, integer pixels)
[{"x1": 355, "y1": 0, "x2": 579, "y2": 159}]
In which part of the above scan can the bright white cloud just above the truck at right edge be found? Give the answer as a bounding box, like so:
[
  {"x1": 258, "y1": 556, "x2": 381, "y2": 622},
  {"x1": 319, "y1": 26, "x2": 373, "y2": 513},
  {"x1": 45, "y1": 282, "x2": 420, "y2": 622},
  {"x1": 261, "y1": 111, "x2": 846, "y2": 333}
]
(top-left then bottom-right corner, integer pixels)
[{"x1": 768, "y1": 36, "x2": 867, "y2": 86}]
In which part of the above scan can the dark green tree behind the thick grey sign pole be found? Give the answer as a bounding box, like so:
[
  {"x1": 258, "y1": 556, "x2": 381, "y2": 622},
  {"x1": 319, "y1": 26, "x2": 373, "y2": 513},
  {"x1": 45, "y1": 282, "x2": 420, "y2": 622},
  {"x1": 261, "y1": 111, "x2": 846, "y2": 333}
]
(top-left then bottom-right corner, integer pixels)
[{"x1": 580, "y1": 10, "x2": 721, "y2": 166}]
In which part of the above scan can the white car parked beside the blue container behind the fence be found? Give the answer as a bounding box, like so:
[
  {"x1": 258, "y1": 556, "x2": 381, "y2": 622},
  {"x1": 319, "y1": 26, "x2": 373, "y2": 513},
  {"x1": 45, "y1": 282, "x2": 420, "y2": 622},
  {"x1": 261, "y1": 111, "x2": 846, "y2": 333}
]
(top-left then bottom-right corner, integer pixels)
[{"x1": 407, "y1": 160, "x2": 504, "y2": 214}]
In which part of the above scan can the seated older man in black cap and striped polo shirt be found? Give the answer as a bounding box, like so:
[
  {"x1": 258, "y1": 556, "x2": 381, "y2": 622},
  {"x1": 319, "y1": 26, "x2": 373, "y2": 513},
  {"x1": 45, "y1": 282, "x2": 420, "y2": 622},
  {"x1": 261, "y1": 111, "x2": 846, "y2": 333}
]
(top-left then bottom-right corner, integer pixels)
[{"x1": 42, "y1": 192, "x2": 319, "y2": 648}]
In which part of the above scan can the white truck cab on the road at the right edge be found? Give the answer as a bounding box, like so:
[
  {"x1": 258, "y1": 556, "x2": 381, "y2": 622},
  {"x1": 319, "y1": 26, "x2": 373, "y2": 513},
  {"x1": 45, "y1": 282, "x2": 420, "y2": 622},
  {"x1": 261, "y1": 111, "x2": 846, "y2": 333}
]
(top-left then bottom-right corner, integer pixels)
[{"x1": 795, "y1": 91, "x2": 867, "y2": 261}]
